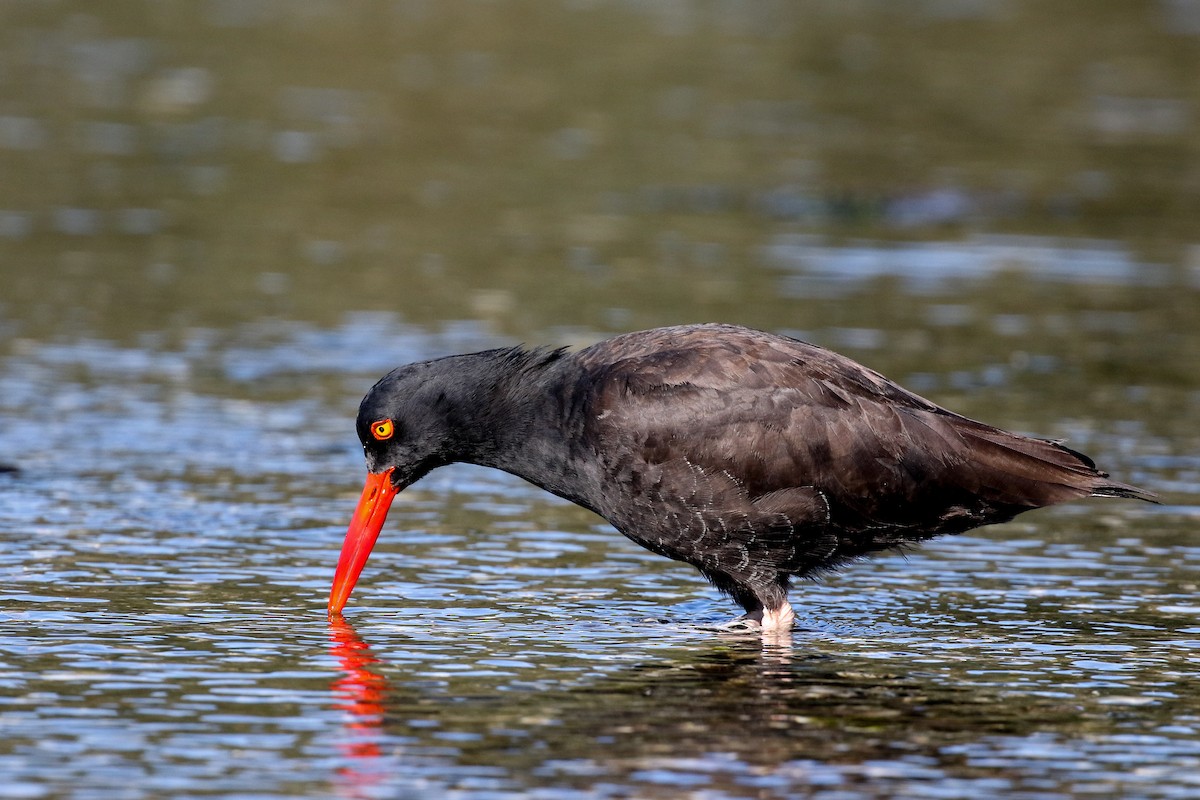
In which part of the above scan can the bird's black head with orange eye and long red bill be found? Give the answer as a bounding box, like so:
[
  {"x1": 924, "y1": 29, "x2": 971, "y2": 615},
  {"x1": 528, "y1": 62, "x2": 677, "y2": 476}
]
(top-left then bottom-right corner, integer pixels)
[{"x1": 329, "y1": 360, "x2": 462, "y2": 615}]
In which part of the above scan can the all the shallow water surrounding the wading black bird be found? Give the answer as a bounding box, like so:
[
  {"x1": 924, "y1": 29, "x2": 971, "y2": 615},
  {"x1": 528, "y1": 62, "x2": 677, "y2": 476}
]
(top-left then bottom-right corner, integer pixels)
[{"x1": 0, "y1": 0, "x2": 1200, "y2": 800}]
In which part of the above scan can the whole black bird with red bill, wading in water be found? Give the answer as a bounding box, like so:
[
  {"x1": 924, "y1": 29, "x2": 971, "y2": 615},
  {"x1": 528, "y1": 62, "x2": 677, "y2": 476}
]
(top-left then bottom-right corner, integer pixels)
[{"x1": 329, "y1": 325, "x2": 1154, "y2": 631}]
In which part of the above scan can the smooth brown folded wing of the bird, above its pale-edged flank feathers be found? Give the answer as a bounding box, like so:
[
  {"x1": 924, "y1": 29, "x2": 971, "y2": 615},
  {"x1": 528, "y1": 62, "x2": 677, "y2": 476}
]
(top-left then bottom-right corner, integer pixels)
[{"x1": 578, "y1": 325, "x2": 1136, "y2": 549}]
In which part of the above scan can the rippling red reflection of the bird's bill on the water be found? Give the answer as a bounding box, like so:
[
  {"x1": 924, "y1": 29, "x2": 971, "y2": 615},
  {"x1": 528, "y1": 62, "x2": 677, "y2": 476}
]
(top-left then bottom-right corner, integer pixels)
[{"x1": 329, "y1": 615, "x2": 391, "y2": 798}]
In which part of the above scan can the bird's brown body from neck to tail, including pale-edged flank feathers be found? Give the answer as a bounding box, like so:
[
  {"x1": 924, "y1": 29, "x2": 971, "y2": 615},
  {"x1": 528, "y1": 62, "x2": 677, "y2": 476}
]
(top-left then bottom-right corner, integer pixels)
[{"x1": 574, "y1": 325, "x2": 1152, "y2": 573}]
